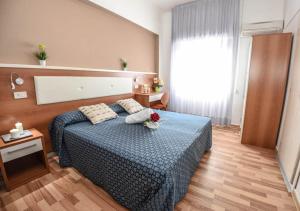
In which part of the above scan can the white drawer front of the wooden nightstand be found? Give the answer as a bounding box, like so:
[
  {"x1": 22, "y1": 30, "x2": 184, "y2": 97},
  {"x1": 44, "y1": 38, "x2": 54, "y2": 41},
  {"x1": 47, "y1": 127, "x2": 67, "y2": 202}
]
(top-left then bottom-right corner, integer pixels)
[{"x1": 0, "y1": 138, "x2": 43, "y2": 162}]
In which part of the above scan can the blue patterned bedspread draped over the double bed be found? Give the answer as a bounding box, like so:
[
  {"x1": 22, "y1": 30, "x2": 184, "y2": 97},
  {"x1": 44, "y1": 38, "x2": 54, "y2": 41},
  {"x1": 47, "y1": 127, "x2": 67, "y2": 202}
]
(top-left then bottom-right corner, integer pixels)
[{"x1": 50, "y1": 105, "x2": 212, "y2": 210}]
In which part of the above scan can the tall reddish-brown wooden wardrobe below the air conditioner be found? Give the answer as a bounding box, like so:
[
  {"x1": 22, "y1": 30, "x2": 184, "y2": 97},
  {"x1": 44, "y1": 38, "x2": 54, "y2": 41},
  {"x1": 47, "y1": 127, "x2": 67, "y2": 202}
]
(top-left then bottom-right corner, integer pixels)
[{"x1": 242, "y1": 33, "x2": 292, "y2": 149}]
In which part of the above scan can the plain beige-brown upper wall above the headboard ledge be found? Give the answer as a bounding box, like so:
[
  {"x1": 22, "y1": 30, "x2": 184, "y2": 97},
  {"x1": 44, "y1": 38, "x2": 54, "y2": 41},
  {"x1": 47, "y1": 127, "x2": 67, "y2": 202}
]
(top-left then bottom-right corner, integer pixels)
[{"x1": 0, "y1": 0, "x2": 158, "y2": 72}]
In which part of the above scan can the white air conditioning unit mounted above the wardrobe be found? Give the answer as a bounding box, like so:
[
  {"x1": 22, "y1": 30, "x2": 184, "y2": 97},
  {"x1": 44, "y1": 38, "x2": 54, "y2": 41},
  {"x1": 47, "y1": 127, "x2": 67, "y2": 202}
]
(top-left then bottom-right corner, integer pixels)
[{"x1": 241, "y1": 20, "x2": 283, "y2": 36}]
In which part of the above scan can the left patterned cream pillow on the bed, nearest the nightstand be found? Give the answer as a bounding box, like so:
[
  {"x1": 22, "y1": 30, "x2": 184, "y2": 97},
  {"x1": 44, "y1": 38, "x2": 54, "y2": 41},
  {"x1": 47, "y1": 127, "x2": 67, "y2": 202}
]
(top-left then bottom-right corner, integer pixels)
[{"x1": 79, "y1": 103, "x2": 118, "y2": 124}]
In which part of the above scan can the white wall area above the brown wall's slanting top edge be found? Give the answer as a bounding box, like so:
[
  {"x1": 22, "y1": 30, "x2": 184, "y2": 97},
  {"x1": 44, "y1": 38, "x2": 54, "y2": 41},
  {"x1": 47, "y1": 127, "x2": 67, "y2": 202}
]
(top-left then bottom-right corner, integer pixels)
[{"x1": 88, "y1": 0, "x2": 161, "y2": 34}]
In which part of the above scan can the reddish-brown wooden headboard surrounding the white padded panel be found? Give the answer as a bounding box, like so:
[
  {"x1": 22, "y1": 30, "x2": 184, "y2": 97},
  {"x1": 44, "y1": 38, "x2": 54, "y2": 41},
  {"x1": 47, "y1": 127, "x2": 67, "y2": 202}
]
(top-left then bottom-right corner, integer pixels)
[{"x1": 0, "y1": 67, "x2": 156, "y2": 152}]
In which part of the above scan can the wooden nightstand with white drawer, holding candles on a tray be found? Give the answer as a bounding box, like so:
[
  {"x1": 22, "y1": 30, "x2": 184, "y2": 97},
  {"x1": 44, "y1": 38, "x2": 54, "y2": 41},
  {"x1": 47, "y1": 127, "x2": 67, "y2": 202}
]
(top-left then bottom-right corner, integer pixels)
[{"x1": 0, "y1": 129, "x2": 49, "y2": 191}]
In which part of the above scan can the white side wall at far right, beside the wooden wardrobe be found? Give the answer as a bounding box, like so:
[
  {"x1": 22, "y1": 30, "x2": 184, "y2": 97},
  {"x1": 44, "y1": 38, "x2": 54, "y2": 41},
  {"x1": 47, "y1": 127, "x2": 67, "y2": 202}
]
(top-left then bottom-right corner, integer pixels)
[{"x1": 277, "y1": 0, "x2": 300, "y2": 190}]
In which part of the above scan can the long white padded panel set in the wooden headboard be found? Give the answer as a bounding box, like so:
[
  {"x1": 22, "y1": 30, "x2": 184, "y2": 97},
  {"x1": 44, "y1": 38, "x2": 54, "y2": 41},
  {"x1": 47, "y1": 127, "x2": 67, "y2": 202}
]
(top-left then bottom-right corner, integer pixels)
[{"x1": 34, "y1": 76, "x2": 133, "y2": 105}]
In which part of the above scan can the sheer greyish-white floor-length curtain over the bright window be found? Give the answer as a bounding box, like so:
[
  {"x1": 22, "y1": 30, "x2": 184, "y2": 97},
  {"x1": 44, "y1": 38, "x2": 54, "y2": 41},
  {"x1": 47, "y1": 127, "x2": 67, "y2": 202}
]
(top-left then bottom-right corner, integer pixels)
[{"x1": 170, "y1": 0, "x2": 239, "y2": 125}]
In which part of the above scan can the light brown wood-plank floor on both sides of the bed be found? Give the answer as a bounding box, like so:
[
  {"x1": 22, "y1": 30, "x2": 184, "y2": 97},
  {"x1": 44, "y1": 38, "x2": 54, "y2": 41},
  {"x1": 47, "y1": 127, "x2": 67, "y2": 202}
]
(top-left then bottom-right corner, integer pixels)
[{"x1": 0, "y1": 128, "x2": 296, "y2": 211}]
